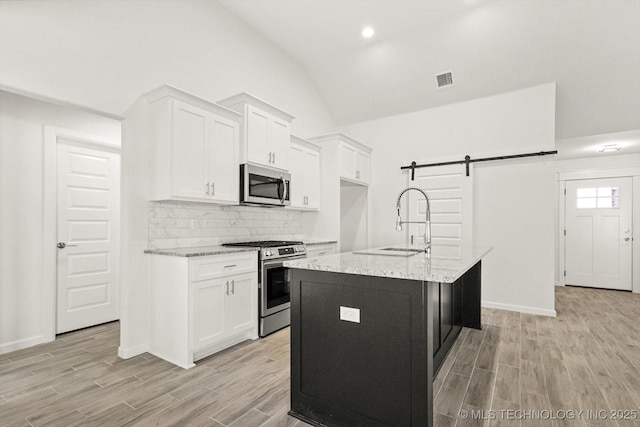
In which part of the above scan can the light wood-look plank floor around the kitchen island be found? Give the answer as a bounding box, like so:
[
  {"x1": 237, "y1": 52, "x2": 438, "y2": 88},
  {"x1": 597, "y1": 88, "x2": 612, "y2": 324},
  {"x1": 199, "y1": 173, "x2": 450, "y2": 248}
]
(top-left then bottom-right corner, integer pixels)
[{"x1": 0, "y1": 288, "x2": 640, "y2": 427}]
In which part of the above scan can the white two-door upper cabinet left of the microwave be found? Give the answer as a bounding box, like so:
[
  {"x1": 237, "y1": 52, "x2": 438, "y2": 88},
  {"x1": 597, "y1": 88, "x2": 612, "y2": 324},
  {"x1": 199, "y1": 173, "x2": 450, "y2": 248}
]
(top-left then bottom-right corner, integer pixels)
[{"x1": 147, "y1": 86, "x2": 242, "y2": 204}]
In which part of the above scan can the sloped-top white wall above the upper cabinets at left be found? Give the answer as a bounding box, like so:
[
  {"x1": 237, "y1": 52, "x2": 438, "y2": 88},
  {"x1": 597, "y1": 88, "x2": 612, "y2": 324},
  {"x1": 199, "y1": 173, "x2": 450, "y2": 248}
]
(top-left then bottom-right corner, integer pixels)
[{"x1": 0, "y1": 0, "x2": 333, "y2": 137}]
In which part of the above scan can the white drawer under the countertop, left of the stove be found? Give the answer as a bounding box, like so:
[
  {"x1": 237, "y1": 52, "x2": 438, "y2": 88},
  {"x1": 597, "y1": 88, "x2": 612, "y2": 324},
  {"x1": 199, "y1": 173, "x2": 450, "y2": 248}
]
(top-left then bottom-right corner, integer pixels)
[{"x1": 190, "y1": 252, "x2": 258, "y2": 282}]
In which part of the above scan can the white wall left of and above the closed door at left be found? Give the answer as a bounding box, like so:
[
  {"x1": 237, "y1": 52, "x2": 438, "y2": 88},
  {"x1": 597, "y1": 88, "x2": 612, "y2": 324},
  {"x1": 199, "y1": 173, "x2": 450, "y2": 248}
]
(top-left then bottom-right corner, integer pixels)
[{"x1": 0, "y1": 91, "x2": 120, "y2": 353}]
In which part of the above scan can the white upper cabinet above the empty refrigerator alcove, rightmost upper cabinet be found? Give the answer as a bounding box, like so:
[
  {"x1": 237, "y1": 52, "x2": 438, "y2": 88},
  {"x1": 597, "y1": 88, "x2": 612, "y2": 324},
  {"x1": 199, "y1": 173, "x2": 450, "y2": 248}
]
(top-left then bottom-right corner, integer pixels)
[{"x1": 310, "y1": 133, "x2": 371, "y2": 185}]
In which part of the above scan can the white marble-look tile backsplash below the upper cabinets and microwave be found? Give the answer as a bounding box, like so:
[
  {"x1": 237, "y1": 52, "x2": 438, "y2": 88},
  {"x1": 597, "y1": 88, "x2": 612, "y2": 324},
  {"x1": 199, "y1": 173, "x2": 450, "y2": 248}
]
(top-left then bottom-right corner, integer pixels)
[{"x1": 148, "y1": 202, "x2": 302, "y2": 249}]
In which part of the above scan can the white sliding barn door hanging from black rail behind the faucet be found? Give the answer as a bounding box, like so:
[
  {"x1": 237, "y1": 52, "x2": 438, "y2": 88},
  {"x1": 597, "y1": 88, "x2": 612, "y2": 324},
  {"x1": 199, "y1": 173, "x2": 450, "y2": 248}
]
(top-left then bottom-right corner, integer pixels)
[{"x1": 402, "y1": 165, "x2": 473, "y2": 258}]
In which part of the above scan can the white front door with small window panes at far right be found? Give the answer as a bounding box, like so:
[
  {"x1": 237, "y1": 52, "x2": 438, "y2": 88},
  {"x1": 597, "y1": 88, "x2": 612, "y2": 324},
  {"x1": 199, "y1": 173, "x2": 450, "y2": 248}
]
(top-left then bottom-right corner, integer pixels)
[{"x1": 565, "y1": 177, "x2": 633, "y2": 290}]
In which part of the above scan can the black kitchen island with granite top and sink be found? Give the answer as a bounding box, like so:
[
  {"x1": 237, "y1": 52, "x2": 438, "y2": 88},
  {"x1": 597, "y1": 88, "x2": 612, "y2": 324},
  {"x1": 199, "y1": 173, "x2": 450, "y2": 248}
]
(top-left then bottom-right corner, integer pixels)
[{"x1": 285, "y1": 246, "x2": 490, "y2": 427}]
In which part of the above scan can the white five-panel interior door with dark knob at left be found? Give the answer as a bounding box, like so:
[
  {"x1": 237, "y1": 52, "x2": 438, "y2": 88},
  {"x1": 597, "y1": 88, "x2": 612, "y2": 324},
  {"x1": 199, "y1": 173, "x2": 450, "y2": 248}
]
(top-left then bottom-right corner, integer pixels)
[{"x1": 56, "y1": 143, "x2": 120, "y2": 333}]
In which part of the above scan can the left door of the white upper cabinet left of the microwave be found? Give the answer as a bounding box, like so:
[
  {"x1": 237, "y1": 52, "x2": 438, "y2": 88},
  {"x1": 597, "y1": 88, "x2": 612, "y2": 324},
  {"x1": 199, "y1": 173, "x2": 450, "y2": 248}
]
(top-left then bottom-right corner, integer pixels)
[{"x1": 171, "y1": 101, "x2": 211, "y2": 199}]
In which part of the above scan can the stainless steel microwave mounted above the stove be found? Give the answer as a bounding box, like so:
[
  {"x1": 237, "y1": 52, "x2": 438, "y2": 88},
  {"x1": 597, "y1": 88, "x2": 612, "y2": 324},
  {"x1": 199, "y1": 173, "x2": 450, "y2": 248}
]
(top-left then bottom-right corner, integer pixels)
[{"x1": 240, "y1": 163, "x2": 291, "y2": 206}]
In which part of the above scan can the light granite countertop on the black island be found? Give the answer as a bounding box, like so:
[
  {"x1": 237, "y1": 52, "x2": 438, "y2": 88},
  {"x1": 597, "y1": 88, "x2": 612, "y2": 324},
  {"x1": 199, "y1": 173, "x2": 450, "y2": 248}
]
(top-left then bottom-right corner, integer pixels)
[{"x1": 284, "y1": 245, "x2": 492, "y2": 283}]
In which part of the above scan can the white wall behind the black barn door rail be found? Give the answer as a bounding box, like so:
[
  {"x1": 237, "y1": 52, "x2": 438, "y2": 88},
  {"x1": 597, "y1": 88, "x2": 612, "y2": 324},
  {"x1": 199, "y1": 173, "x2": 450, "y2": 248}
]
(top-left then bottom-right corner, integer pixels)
[{"x1": 341, "y1": 84, "x2": 555, "y2": 315}]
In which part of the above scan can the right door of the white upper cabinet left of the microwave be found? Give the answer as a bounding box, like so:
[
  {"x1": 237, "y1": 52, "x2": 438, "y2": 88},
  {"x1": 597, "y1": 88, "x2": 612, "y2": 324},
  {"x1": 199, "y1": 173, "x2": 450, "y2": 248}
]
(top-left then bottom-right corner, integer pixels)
[{"x1": 209, "y1": 115, "x2": 239, "y2": 203}]
